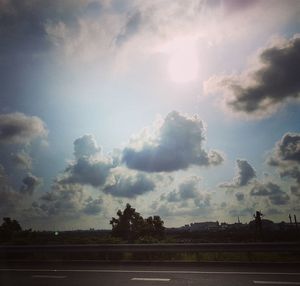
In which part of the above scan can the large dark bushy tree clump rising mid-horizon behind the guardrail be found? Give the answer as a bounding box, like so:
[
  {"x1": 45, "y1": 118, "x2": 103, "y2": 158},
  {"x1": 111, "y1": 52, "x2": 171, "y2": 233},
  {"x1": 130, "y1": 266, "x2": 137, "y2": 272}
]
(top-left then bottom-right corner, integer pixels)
[{"x1": 110, "y1": 204, "x2": 164, "y2": 241}]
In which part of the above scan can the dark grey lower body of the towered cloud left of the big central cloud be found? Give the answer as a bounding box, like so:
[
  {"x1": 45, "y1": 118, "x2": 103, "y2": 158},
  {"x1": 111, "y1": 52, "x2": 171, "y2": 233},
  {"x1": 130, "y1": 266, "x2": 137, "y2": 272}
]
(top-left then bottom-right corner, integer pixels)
[{"x1": 60, "y1": 157, "x2": 113, "y2": 187}]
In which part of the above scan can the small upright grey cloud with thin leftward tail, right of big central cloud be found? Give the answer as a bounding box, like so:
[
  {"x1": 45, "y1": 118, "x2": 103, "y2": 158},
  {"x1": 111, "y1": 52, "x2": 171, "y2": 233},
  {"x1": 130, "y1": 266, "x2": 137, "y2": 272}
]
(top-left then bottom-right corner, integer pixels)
[{"x1": 219, "y1": 159, "x2": 256, "y2": 188}]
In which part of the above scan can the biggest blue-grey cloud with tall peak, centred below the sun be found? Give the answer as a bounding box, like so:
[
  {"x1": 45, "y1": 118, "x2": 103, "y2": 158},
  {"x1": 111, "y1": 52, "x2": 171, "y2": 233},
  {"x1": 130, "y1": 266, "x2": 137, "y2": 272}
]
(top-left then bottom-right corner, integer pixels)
[{"x1": 122, "y1": 111, "x2": 223, "y2": 172}]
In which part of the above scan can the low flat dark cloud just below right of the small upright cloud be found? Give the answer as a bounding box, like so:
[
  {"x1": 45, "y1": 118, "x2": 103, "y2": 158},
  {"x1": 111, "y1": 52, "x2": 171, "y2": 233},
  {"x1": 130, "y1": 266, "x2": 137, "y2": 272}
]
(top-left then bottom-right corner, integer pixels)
[{"x1": 250, "y1": 182, "x2": 290, "y2": 205}]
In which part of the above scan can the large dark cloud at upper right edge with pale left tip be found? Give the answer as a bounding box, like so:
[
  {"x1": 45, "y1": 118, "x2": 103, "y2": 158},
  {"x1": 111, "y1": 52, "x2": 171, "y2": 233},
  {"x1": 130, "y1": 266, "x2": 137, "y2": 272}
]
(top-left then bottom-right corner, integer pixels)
[{"x1": 205, "y1": 34, "x2": 300, "y2": 117}]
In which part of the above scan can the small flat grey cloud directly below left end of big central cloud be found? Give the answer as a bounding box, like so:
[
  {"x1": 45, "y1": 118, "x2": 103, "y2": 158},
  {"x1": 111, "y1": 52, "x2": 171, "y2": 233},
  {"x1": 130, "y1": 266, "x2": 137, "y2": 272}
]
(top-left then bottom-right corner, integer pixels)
[{"x1": 103, "y1": 173, "x2": 155, "y2": 198}]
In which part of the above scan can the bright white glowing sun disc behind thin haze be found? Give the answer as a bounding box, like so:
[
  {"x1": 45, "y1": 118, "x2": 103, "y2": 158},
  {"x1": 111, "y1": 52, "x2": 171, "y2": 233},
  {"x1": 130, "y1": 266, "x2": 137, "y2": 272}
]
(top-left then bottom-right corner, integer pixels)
[{"x1": 167, "y1": 39, "x2": 199, "y2": 83}]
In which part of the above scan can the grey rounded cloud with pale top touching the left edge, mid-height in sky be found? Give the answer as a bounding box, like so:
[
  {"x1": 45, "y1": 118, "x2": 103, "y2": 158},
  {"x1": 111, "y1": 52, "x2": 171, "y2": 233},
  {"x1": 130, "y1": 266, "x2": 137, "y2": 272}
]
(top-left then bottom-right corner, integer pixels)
[{"x1": 0, "y1": 112, "x2": 48, "y2": 144}]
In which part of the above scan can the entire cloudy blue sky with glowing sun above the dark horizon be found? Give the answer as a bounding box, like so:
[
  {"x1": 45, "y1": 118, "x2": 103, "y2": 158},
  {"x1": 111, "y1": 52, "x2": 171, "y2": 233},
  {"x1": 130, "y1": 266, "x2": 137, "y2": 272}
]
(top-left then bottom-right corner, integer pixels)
[{"x1": 0, "y1": 0, "x2": 300, "y2": 230}]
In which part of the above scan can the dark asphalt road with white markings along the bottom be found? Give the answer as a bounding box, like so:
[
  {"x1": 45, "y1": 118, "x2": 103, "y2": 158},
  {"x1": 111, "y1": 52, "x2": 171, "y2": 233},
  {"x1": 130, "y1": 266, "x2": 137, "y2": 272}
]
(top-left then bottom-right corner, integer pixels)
[{"x1": 0, "y1": 261, "x2": 300, "y2": 286}]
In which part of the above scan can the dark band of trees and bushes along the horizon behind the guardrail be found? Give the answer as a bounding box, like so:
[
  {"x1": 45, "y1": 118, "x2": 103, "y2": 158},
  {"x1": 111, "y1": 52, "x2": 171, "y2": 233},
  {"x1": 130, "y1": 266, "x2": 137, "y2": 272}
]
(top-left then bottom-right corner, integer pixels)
[{"x1": 0, "y1": 204, "x2": 300, "y2": 245}]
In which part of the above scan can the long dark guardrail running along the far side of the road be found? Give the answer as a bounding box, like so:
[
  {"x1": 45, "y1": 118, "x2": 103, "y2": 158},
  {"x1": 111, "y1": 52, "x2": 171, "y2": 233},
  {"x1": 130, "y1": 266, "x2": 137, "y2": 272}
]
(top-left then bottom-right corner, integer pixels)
[{"x1": 0, "y1": 243, "x2": 300, "y2": 260}]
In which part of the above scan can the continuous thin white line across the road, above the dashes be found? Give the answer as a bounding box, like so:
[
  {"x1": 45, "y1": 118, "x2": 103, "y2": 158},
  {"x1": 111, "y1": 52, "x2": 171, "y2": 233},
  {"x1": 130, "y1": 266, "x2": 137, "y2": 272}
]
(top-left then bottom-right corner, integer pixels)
[{"x1": 0, "y1": 268, "x2": 300, "y2": 276}]
